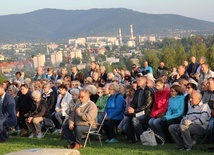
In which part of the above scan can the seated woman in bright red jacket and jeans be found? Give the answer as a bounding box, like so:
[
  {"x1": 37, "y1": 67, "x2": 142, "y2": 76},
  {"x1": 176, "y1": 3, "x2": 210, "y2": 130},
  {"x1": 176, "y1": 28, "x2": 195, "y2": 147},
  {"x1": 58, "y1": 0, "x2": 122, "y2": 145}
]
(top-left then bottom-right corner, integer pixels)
[{"x1": 149, "y1": 79, "x2": 170, "y2": 138}]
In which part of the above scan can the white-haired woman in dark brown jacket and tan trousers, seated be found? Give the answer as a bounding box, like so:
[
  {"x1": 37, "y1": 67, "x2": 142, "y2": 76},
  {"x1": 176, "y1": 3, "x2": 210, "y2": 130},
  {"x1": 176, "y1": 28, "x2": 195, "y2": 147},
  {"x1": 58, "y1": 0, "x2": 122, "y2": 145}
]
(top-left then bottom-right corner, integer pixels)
[{"x1": 25, "y1": 90, "x2": 51, "y2": 138}]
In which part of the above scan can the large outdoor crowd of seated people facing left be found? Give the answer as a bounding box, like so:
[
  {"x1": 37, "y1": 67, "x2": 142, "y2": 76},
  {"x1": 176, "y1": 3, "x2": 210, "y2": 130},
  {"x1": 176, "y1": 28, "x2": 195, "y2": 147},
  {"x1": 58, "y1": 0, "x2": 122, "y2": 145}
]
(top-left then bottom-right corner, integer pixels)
[{"x1": 0, "y1": 56, "x2": 214, "y2": 150}]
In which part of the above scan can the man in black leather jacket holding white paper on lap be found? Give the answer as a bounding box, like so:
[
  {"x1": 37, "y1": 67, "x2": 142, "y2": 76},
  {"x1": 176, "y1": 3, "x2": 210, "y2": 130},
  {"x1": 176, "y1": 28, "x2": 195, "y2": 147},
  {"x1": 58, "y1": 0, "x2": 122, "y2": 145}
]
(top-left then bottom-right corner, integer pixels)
[{"x1": 125, "y1": 76, "x2": 153, "y2": 142}]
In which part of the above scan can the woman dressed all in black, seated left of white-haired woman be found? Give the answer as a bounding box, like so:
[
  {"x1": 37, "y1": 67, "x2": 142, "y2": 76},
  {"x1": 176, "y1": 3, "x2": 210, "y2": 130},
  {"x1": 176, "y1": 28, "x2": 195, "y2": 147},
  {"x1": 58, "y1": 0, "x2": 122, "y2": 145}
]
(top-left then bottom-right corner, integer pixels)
[{"x1": 16, "y1": 84, "x2": 33, "y2": 135}]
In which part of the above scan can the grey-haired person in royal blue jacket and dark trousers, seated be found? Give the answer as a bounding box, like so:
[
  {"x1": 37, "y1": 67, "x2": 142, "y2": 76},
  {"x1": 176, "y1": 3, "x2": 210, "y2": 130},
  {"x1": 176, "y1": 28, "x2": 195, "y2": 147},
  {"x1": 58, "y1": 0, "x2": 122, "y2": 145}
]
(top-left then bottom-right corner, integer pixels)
[{"x1": 103, "y1": 83, "x2": 126, "y2": 143}]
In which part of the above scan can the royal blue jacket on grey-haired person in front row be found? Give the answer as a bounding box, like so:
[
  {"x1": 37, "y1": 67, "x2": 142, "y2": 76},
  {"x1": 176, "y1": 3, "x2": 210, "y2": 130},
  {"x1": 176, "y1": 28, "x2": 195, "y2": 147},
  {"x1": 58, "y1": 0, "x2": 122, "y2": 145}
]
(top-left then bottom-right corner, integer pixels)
[{"x1": 105, "y1": 93, "x2": 126, "y2": 120}]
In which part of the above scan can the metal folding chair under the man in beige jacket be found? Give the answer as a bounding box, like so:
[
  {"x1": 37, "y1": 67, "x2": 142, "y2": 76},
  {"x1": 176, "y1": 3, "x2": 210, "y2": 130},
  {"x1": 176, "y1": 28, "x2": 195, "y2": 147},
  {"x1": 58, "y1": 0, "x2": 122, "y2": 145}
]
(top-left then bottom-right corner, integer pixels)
[{"x1": 83, "y1": 114, "x2": 107, "y2": 148}]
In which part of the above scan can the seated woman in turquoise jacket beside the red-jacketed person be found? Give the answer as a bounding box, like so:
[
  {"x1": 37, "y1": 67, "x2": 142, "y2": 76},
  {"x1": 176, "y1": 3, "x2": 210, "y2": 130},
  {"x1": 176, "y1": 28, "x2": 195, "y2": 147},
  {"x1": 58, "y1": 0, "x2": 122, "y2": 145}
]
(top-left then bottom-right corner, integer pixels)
[{"x1": 159, "y1": 85, "x2": 184, "y2": 142}]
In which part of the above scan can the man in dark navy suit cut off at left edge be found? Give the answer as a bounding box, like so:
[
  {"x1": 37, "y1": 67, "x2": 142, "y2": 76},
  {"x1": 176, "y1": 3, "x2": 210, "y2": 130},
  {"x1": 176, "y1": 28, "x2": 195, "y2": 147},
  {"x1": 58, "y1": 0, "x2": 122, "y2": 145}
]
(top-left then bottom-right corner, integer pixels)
[{"x1": 0, "y1": 85, "x2": 17, "y2": 142}]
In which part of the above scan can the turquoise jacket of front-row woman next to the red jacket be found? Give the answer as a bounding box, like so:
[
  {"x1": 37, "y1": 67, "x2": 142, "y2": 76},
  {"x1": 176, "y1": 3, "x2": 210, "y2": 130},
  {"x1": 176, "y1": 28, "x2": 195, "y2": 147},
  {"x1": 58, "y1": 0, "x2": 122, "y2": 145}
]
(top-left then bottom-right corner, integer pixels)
[{"x1": 165, "y1": 95, "x2": 184, "y2": 120}]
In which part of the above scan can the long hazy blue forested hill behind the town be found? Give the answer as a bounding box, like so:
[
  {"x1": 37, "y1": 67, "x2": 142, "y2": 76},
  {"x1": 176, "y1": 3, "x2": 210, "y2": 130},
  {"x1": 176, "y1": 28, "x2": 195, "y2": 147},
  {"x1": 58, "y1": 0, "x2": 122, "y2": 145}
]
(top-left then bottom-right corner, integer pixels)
[{"x1": 0, "y1": 8, "x2": 214, "y2": 43}]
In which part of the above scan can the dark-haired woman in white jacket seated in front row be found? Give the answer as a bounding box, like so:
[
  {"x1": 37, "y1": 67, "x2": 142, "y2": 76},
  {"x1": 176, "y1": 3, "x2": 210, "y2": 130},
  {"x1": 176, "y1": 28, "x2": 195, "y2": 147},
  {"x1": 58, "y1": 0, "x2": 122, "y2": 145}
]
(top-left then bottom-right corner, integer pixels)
[{"x1": 53, "y1": 84, "x2": 72, "y2": 133}]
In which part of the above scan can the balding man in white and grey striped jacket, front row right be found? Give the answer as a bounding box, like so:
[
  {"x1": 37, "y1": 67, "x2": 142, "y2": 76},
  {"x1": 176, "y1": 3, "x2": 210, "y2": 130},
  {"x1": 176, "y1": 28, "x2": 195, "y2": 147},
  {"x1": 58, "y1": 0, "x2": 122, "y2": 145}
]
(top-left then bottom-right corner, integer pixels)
[{"x1": 169, "y1": 91, "x2": 211, "y2": 151}]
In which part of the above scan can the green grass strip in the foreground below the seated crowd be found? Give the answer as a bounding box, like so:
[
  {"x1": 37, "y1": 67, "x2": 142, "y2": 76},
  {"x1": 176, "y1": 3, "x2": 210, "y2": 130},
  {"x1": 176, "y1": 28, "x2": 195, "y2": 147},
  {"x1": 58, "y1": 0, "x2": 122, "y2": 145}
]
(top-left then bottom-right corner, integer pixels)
[{"x1": 0, "y1": 134, "x2": 212, "y2": 155}]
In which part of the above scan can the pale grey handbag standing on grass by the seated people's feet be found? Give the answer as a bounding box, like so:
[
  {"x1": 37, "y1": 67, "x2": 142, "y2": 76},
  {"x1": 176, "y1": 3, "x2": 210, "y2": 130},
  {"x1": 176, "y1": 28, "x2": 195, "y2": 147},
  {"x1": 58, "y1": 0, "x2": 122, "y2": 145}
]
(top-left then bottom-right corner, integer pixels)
[{"x1": 140, "y1": 128, "x2": 165, "y2": 146}]
